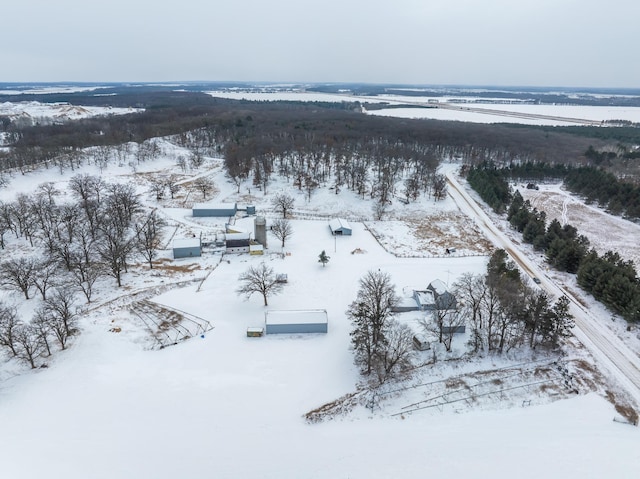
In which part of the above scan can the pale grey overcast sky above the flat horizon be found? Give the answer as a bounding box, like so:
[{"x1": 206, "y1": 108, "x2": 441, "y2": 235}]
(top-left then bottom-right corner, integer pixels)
[{"x1": 0, "y1": 0, "x2": 640, "y2": 88}]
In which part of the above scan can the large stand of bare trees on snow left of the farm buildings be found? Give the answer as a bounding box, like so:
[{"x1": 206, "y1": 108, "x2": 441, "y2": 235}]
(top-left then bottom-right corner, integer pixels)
[{"x1": 0, "y1": 175, "x2": 164, "y2": 367}]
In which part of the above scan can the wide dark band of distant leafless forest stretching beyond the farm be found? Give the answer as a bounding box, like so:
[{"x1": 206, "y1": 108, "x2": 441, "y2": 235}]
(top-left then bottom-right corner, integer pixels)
[{"x1": 2, "y1": 88, "x2": 601, "y2": 175}]
